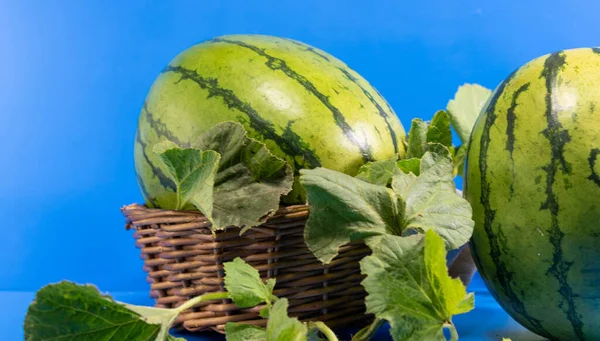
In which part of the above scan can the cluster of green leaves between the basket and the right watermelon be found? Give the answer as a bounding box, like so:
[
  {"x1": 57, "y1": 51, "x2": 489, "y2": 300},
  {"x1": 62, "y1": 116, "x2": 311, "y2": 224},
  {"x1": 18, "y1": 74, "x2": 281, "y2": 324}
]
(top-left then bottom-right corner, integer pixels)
[{"x1": 300, "y1": 85, "x2": 490, "y2": 341}]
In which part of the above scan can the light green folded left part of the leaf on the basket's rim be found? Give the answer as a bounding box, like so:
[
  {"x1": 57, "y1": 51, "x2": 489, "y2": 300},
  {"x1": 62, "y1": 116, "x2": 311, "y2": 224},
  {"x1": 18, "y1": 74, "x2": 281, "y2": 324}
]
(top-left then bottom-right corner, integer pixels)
[{"x1": 153, "y1": 141, "x2": 221, "y2": 212}]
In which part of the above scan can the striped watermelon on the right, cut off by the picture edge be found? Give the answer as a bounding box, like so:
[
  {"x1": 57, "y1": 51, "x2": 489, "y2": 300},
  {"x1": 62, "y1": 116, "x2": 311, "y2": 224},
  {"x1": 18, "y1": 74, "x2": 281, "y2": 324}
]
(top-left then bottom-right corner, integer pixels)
[{"x1": 465, "y1": 48, "x2": 600, "y2": 341}]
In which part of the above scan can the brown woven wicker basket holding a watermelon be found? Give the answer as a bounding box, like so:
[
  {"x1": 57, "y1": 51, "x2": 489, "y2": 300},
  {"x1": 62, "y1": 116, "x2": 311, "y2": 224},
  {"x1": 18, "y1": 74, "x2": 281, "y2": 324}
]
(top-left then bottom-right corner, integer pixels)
[{"x1": 121, "y1": 204, "x2": 373, "y2": 333}]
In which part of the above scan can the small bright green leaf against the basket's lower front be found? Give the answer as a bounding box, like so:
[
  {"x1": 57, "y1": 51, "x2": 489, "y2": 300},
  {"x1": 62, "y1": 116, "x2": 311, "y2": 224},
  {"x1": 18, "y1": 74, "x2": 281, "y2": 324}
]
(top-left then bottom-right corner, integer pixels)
[{"x1": 223, "y1": 257, "x2": 275, "y2": 308}]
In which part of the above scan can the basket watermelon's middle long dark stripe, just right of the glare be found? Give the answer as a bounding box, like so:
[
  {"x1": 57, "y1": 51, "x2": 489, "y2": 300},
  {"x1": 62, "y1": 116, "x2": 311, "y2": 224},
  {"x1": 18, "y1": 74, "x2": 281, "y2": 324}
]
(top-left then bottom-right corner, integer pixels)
[{"x1": 212, "y1": 38, "x2": 374, "y2": 162}]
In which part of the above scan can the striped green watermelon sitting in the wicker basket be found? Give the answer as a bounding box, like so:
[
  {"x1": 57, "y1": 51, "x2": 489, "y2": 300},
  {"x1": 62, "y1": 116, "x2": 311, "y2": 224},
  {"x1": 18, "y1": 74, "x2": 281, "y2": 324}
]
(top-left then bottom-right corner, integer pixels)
[{"x1": 135, "y1": 35, "x2": 405, "y2": 207}]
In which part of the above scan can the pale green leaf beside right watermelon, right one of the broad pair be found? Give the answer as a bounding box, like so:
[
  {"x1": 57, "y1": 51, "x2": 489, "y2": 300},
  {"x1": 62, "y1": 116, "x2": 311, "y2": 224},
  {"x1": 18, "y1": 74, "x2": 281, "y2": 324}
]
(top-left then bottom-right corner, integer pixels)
[{"x1": 392, "y1": 152, "x2": 475, "y2": 250}]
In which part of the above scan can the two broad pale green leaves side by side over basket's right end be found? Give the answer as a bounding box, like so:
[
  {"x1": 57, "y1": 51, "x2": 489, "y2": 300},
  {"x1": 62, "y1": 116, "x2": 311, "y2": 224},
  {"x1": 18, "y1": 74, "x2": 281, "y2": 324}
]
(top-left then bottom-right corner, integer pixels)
[{"x1": 300, "y1": 152, "x2": 474, "y2": 264}]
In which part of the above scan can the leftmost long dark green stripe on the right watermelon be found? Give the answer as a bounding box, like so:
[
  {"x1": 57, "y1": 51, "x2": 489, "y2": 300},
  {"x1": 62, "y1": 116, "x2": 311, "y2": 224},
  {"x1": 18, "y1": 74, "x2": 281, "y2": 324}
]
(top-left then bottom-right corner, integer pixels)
[{"x1": 476, "y1": 70, "x2": 549, "y2": 336}]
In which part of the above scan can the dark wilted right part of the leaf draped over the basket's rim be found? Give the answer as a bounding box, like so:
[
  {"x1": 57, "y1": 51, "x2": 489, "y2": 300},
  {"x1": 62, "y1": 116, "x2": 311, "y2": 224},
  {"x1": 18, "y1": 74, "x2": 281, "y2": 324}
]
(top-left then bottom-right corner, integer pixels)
[{"x1": 192, "y1": 122, "x2": 294, "y2": 233}]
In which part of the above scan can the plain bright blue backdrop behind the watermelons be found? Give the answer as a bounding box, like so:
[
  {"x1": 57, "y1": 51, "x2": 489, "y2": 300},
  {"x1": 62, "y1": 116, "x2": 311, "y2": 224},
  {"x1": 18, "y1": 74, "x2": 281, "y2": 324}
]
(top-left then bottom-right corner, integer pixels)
[{"x1": 0, "y1": 0, "x2": 600, "y2": 339}]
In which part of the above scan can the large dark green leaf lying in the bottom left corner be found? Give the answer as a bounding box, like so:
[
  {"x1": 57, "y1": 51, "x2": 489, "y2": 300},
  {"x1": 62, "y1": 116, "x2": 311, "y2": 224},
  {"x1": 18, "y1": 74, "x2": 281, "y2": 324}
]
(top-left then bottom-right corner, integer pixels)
[{"x1": 24, "y1": 281, "x2": 178, "y2": 341}]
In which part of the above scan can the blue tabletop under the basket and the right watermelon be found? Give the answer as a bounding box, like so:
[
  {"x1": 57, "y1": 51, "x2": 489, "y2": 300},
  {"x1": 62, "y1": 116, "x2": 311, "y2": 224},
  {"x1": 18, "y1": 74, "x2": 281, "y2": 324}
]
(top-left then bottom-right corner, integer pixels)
[{"x1": 5, "y1": 274, "x2": 545, "y2": 341}]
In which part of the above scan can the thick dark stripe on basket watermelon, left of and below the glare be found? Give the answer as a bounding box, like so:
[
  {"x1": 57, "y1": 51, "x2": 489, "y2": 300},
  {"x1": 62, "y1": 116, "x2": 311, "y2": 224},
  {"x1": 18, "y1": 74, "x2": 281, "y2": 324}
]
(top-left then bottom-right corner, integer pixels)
[{"x1": 163, "y1": 65, "x2": 321, "y2": 170}]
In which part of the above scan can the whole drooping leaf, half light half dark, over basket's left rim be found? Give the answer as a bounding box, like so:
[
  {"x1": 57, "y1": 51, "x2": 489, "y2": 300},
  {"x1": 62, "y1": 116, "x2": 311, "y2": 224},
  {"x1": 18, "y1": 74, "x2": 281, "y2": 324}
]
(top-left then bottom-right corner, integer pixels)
[{"x1": 154, "y1": 122, "x2": 294, "y2": 233}]
